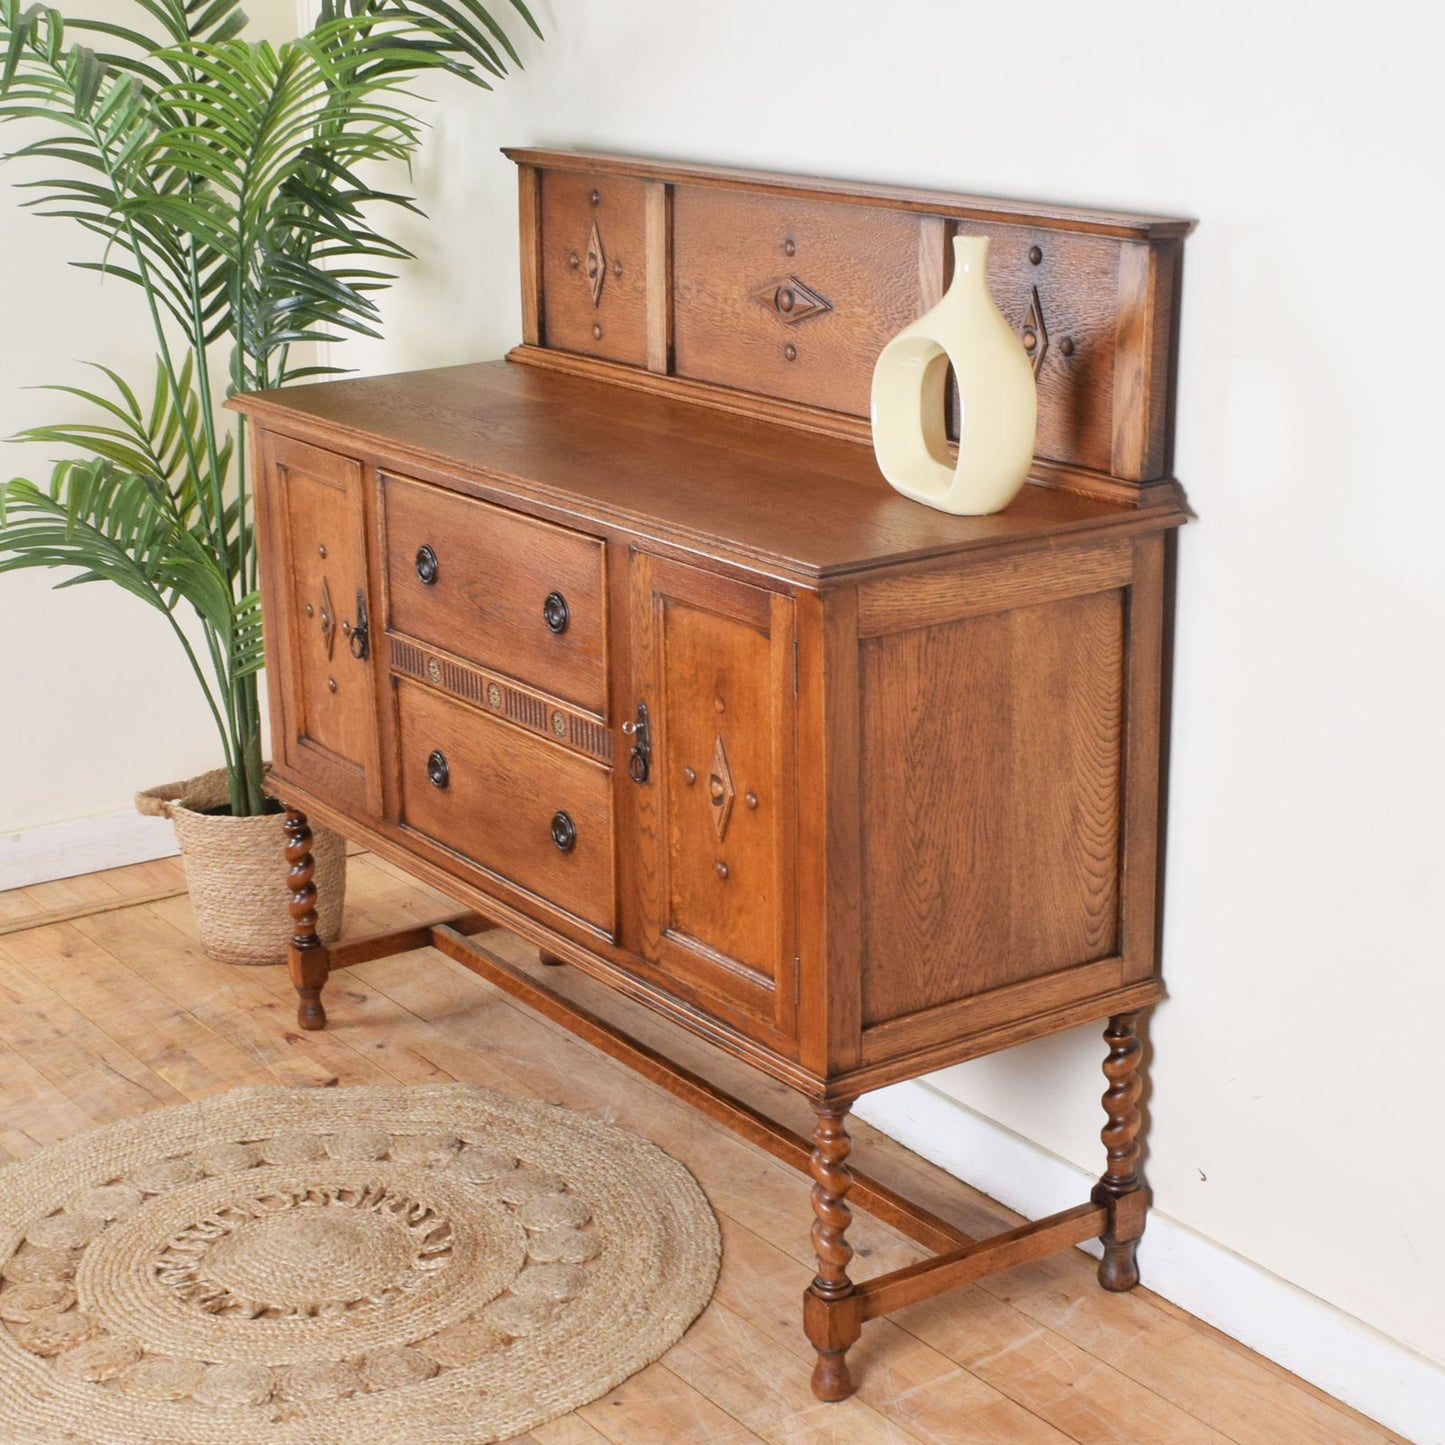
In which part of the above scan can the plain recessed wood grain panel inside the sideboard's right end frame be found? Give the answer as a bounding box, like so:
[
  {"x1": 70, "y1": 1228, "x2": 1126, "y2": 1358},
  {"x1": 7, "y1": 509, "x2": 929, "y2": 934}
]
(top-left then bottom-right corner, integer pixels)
[{"x1": 861, "y1": 591, "x2": 1124, "y2": 1025}]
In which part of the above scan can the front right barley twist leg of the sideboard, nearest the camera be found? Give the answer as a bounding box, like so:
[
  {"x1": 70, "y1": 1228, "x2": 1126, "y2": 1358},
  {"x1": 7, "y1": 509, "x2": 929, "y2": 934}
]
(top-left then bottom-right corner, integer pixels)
[{"x1": 803, "y1": 1100, "x2": 863, "y2": 1400}]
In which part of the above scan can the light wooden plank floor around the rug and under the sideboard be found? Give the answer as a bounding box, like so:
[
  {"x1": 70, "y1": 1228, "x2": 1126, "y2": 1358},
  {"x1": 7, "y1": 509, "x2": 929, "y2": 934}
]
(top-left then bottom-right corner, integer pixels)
[{"x1": 0, "y1": 854, "x2": 1407, "y2": 1445}]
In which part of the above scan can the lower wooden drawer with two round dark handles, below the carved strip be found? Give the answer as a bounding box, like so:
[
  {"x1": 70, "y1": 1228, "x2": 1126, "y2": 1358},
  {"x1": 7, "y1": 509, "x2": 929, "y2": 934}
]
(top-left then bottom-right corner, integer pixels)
[{"x1": 396, "y1": 678, "x2": 616, "y2": 936}]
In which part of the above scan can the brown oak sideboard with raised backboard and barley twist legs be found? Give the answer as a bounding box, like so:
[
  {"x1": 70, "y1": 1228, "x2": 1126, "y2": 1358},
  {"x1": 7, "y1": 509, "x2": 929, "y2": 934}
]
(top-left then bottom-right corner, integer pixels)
[{"x1": 236, "y1": 150, "x2": 1189, "y2": 1400}]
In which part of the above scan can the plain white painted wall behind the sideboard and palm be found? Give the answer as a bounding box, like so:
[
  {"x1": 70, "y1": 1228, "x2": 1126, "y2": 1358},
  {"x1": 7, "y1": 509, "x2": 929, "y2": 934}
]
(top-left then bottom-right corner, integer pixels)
[{"x1": 0, "y1": 0, "x2": 1445, "y2": 1421}]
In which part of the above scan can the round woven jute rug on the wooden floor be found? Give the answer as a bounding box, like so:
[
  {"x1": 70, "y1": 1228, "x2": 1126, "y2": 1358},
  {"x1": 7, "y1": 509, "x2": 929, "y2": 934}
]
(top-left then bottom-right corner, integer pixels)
[{"x1": 0, "y1": 1084, "x2": 720, "y2": 1445}]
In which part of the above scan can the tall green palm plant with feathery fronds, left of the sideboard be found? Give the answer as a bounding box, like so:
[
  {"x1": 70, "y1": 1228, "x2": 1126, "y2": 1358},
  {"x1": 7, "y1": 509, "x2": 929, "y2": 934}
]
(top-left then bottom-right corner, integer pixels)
[{"x1": 0, "y1": 0, "x2": 540, "y2": 815}]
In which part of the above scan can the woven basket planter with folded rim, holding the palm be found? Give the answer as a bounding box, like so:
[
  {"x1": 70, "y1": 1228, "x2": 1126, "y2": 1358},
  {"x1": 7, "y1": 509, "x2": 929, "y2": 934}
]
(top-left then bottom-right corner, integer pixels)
[{"x1": 136, "y1": 769, "x2": 347, "y2": 964}]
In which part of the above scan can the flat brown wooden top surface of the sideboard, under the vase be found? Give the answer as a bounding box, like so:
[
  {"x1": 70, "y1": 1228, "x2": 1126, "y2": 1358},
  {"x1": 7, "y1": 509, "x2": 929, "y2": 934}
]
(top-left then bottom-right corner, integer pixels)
[{"x1": 234, "y1": 361, "x2": 1185, "y2": 578}]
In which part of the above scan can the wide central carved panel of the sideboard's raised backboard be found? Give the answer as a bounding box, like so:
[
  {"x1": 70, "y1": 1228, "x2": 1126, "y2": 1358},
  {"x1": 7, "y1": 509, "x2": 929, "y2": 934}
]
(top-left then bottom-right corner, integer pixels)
[{"x1": 673, "y1": 186, "x2": 922, "y2": 415}]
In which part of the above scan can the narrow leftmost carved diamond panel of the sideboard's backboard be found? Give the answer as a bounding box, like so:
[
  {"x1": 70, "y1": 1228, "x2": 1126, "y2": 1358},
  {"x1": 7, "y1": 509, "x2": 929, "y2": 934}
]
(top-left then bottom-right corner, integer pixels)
[{"x1": 542, "y1": 171, "x2": 647, "y2": 367}]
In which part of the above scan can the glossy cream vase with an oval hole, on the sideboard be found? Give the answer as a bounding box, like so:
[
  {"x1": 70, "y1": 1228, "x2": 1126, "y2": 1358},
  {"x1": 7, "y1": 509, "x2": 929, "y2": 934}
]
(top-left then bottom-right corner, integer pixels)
[{"x1": 873, "y1": 236, "x2": 1039, "y2": 516}]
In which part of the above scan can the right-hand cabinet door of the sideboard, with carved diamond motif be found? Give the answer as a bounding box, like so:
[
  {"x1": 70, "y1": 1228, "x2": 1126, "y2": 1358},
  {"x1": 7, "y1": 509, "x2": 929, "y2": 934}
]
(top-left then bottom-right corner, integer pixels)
[{"x1": 633, "y1": 553, "x2": 798, "y2": 1038}]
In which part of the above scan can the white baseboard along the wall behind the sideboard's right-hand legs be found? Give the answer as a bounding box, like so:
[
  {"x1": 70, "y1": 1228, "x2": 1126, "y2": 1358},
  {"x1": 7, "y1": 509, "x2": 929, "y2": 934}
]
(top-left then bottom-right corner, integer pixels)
[{"x1": 857, "y1": 1081, "x2": 1445, "y2": 1445}]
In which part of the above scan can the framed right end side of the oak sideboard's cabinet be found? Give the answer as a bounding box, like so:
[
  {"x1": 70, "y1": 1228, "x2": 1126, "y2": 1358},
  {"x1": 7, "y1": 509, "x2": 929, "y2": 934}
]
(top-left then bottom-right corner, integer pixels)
[{"x1": 858, "y1": 538, "x2": 1162, "y2": 1064}]
